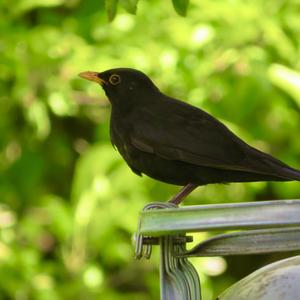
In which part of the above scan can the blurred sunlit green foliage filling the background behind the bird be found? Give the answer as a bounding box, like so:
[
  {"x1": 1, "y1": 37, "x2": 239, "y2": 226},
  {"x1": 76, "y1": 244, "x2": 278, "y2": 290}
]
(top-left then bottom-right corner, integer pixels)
[{"x1": 0, "y1": 0, "x2": 300, "y2": 300}]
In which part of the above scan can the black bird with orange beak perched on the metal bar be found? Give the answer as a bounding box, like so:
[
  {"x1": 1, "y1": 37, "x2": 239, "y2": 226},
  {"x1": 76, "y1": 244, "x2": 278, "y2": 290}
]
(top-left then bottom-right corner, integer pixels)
[{"x1": 79, "y1": 68, "x2": 300, "y2": 204}]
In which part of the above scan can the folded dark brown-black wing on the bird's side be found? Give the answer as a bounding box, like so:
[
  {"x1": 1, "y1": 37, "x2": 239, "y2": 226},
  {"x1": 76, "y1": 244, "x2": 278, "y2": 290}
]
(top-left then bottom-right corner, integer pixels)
[{"x1": 130, "y1": 100, "x2": 265, "y2": 173}]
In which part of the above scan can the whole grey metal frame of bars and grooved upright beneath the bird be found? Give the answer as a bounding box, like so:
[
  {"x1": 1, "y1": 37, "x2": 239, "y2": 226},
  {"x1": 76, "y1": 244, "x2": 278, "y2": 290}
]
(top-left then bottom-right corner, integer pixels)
[{"x1": 136, "y1": 200, "x2": 300, "y2": 300}]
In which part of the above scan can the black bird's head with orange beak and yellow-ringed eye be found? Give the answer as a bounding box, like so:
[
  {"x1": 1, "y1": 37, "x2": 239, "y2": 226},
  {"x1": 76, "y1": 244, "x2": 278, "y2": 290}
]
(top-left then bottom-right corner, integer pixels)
[{"x1": 79, "y1": 68, "x2": 158, "y2": 107}]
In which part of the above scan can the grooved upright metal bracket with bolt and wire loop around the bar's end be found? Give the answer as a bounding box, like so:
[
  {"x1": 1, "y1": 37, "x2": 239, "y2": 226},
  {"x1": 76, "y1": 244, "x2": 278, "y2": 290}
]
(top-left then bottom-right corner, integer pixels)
[{"x1": 135, "y1": 202, "x2": 201, "y2": 300}]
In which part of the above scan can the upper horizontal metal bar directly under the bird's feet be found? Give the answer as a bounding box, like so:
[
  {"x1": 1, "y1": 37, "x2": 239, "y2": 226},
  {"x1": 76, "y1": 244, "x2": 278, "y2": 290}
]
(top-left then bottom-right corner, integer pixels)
[{"x1": 140, "y1": 200, "x2": 300, "y2": 236}]
